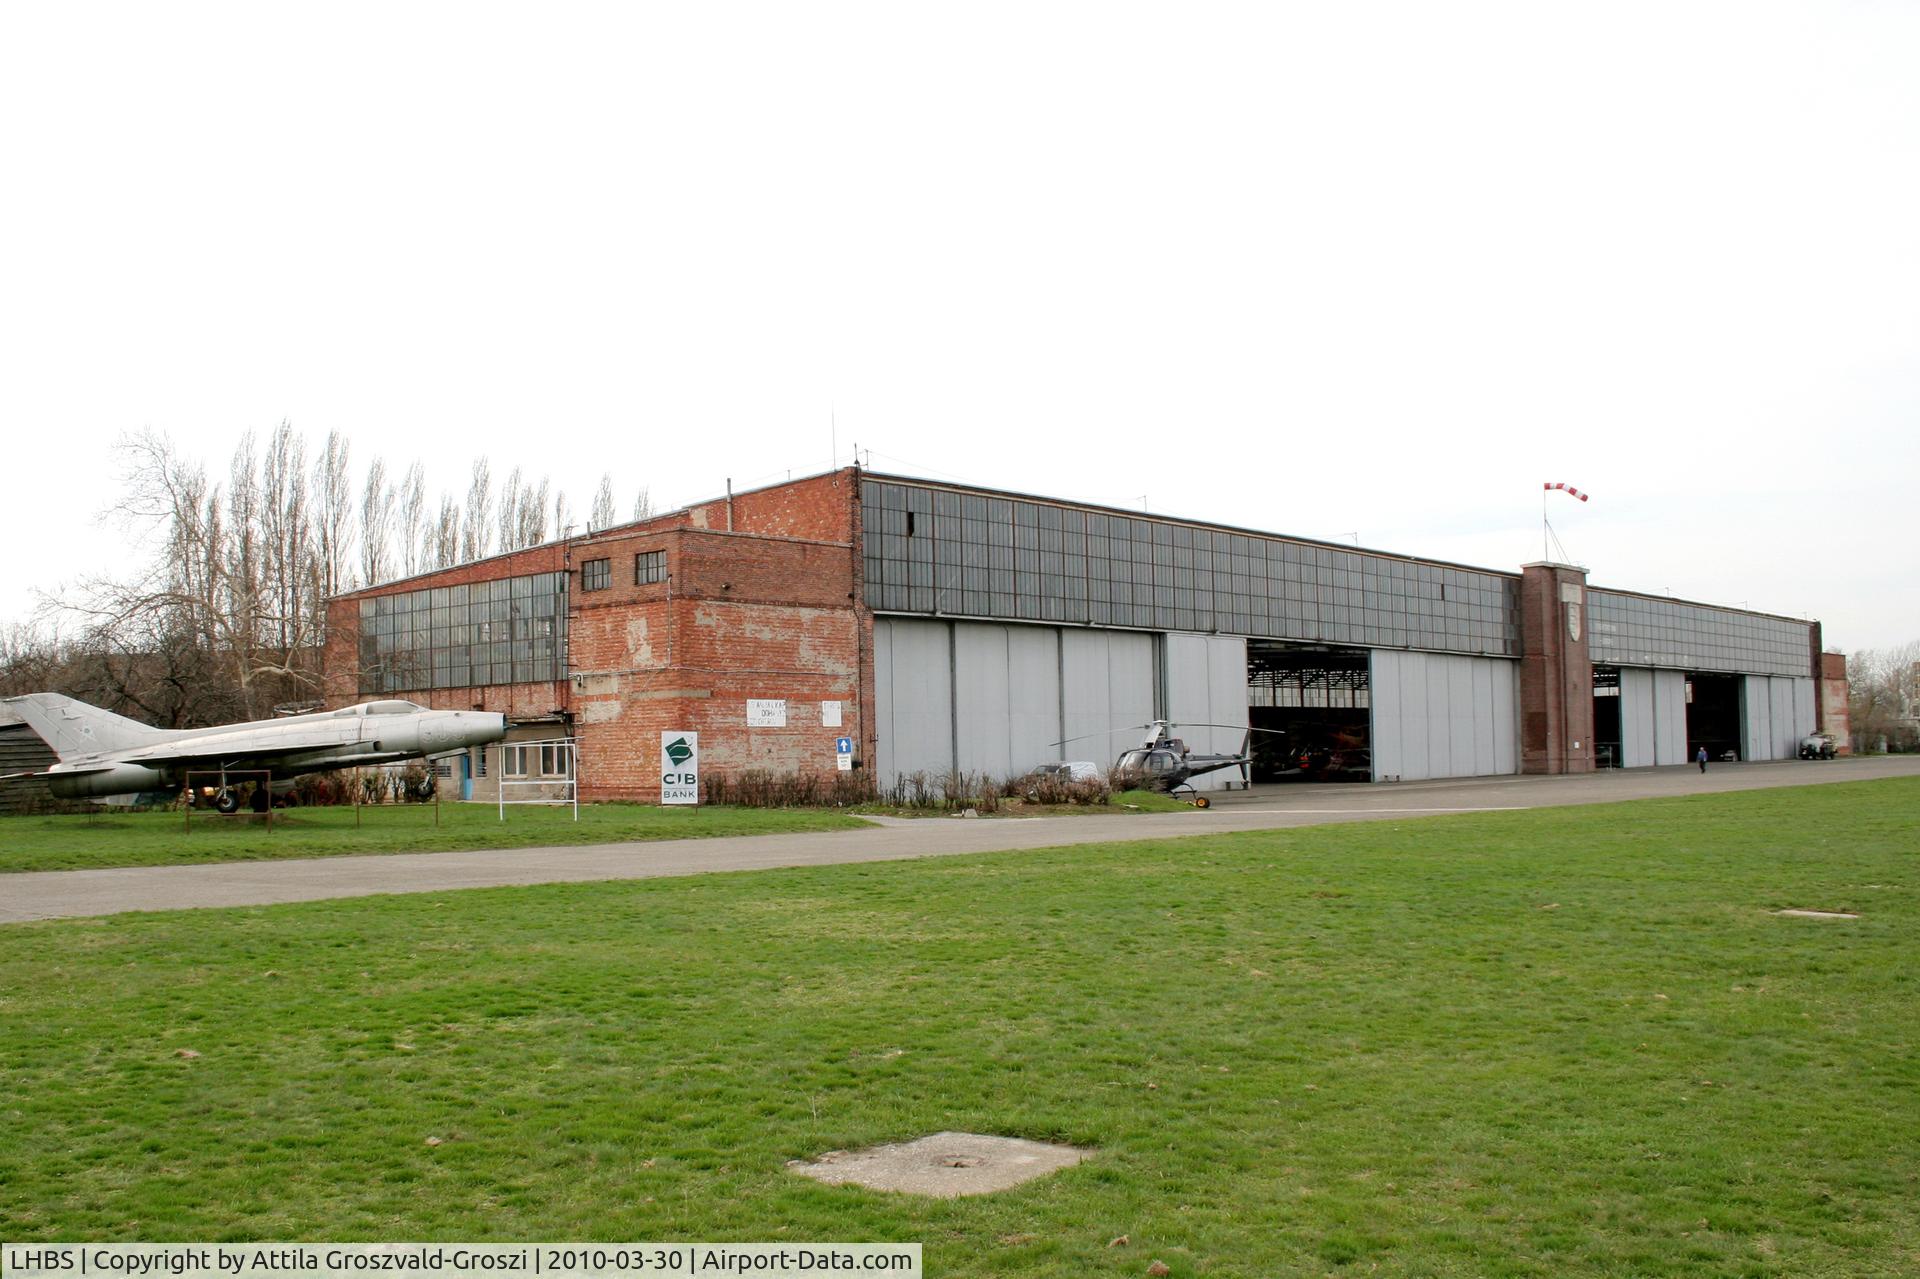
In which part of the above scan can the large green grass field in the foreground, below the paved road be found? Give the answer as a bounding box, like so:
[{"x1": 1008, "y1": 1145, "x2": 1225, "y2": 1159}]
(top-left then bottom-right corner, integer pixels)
[{"x1": 0, "y1": 780, "x2": 1920, "y2": 1277}]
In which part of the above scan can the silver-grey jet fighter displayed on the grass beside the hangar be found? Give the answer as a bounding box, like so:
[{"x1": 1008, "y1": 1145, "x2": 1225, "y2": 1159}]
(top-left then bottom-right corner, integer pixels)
[{"x1": 0, "y1": 693, "x2": 507, "y2": 812}]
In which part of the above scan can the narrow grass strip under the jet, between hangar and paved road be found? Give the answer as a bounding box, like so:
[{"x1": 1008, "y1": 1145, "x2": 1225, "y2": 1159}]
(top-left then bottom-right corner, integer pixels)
[{"x1": 0, "y1": 803, "x2": 864, "y2": 871}]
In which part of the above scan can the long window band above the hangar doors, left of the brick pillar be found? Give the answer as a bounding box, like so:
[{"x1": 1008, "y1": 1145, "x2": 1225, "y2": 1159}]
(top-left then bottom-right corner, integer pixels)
[{"x1": 864, "y1": 480, "x2": 1519, "y2": 655}]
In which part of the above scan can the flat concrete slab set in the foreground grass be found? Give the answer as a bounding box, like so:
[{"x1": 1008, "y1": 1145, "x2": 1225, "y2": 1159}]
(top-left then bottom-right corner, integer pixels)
[{"x1": 787, "y1": 1133, "x2": 1092, "y2": 1198}]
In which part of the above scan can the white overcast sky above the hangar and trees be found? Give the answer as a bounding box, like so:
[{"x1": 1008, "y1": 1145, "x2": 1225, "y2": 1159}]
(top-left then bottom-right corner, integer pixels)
[{"x1": 0, "y1": 0, "x2": 1920, "y2": 649}]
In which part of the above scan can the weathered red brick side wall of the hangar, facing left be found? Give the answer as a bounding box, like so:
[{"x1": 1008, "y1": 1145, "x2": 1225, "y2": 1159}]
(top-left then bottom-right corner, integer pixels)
[{"x1": 324, "y1": 471, "x2": 874, "y2": 801}]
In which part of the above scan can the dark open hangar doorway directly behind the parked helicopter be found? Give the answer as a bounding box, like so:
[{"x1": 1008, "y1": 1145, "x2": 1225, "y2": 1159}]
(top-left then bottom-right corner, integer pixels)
[{"x1": 1246, "y1": 640, "x2": 1373, "y2": 782}]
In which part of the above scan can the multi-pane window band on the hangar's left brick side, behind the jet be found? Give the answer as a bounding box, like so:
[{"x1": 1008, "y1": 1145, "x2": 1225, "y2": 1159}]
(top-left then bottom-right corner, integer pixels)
[{"x1": 359, "y1": 572, "x2": 566, "y2": 693}]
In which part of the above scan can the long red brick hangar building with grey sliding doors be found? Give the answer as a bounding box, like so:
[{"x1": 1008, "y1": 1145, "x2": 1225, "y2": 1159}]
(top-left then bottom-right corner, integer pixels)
[{"x1": 324, "y1": 469, "x2": 1832, "y2": 801}]
